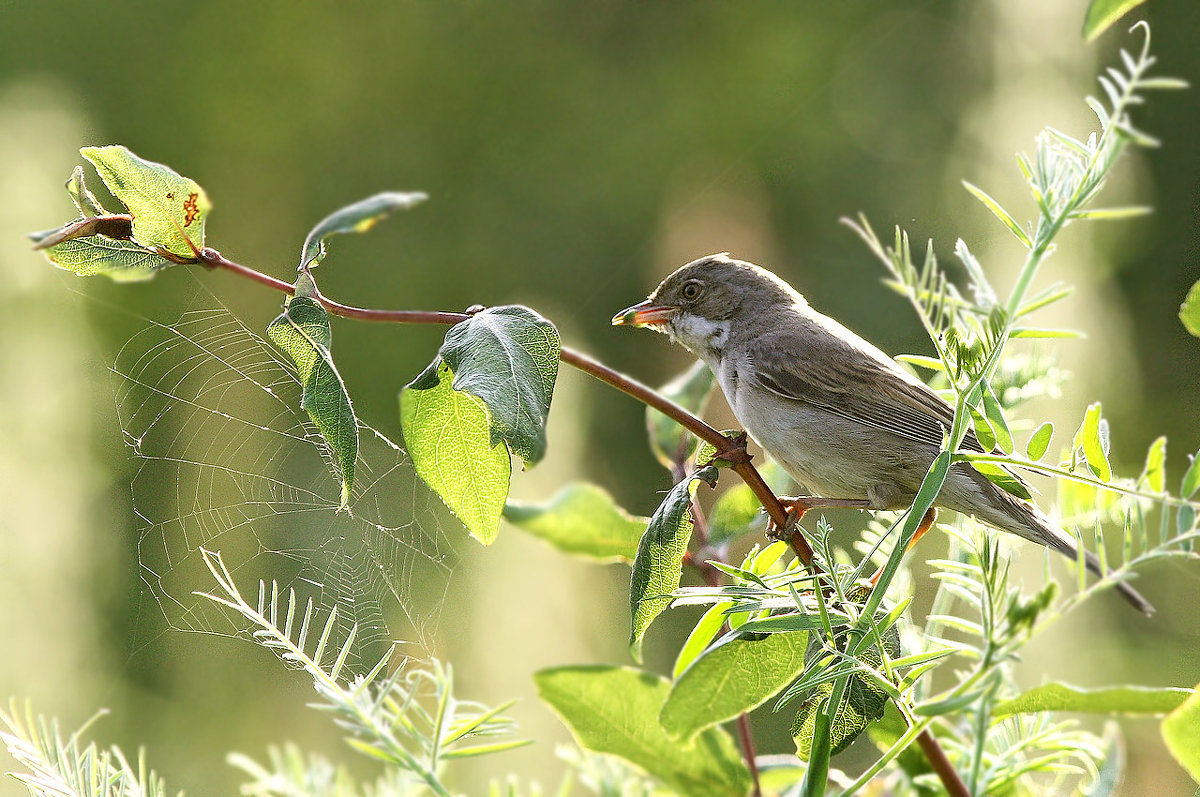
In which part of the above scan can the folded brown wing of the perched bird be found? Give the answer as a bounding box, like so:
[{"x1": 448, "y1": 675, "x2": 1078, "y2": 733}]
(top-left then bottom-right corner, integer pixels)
[{"x1": 749, "y1": 328, "x2": 983, "y2": 451}]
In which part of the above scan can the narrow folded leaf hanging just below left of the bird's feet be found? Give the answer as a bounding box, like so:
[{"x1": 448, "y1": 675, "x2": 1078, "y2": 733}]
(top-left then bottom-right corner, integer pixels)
[{"x1": 629, "y1": 467, "x2": 716, "y2": 661}]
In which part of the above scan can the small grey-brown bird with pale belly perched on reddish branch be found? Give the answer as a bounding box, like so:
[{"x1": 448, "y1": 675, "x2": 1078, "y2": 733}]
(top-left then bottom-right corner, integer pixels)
[{"x1": 612, "y1": 254, "x2": 1153, "y2": 615}]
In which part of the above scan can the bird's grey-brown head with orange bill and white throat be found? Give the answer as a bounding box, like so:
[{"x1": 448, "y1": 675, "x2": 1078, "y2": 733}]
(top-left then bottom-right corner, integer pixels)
[{"x1": 612, "y1": 253, "x2": 804, "y2": 356}]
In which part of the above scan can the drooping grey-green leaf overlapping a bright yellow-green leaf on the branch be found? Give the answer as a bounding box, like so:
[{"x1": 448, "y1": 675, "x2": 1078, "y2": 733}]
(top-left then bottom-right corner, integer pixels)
[{"x1": 417, "y1": 305, "x2": 559, "y2": 465}]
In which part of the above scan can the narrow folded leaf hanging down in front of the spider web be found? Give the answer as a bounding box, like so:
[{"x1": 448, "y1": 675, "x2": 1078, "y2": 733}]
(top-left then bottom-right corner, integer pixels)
[{"x1": 266, "y1": 275, "x2": 359, "y2": 507}]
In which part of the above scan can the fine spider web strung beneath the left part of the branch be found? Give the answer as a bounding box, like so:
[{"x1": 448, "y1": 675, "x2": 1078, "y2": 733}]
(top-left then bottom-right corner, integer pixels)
[{"x1": 110, "y1": 288, "x2": 457, "y2": 663}]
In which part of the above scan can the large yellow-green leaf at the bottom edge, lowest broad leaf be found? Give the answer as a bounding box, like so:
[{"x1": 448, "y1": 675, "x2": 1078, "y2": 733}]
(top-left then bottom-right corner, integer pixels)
[{"x1": 534, "y1": 665, "x2": 750, "y2": 797}]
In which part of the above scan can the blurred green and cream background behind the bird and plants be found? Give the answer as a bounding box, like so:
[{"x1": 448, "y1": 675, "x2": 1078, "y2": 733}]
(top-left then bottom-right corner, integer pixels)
[{"x1": 0, "y1": 0, "x2": 1200, "y2": 795}]
